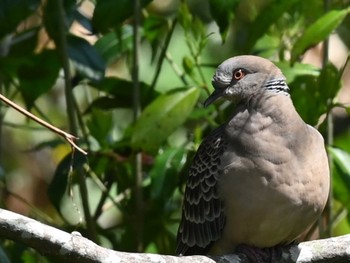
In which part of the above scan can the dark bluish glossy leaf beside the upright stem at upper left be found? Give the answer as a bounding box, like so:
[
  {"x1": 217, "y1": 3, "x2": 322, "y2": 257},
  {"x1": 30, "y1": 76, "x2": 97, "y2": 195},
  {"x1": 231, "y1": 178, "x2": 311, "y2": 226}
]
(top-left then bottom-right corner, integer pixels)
[{"x1": 67, "y1": 35, "x2": 106, "y2": 80}]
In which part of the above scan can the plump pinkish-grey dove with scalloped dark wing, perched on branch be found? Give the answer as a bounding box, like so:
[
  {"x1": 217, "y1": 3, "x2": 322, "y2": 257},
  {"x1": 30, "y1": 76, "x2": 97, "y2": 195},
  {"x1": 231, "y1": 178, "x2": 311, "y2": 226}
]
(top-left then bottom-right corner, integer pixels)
[{"x1": 176, "y1": 55, "x2": 330, "y2": 256}]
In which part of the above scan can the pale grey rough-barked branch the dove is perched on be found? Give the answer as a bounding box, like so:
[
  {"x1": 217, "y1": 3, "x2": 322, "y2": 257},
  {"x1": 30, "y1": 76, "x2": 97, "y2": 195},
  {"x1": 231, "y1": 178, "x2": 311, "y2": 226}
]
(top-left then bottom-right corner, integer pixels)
[{"x1": 0, "y1": 209, "x2": 350, "y2": 263}]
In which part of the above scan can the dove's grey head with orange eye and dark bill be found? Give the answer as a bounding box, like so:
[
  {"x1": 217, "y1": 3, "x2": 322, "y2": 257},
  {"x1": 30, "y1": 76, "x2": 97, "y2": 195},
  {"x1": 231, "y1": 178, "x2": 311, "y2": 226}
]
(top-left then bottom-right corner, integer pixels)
[{"x1": 204, "y1": 56, "x2": 285, "y2": 107}]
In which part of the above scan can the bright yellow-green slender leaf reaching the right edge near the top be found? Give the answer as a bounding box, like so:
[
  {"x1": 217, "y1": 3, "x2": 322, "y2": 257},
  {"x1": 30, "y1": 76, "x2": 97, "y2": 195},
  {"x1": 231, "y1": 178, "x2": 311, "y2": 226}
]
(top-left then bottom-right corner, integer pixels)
[{"x1": 291, "y1": 8, "x2": 350, "y2": 63}]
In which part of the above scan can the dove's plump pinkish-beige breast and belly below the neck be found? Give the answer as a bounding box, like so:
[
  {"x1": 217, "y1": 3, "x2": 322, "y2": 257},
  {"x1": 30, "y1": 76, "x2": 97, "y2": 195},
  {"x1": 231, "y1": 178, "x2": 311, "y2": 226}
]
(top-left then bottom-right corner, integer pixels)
[{"x1": 213, "y1": 109, "x2": 329, "y2": 252}]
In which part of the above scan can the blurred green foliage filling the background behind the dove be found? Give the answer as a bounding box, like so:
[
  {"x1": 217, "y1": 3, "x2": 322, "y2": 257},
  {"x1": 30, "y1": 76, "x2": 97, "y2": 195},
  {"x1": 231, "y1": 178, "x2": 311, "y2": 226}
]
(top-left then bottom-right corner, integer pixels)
[{"x1": 0, "y1": 0, "x2": 350, "y2": 262}]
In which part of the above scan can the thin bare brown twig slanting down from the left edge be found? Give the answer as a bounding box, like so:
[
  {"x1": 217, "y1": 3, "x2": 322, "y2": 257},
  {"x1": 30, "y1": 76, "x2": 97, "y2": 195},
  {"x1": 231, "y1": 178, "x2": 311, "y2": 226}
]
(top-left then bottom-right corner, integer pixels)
[{"x1": 0, "y1": 94, "x2": 87, "y2": 155}]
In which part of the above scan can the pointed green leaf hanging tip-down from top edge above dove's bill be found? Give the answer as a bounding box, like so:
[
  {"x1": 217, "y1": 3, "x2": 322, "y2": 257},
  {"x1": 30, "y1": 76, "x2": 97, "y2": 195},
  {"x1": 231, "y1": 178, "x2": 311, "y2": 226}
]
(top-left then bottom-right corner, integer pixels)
[{"x1": 209, "y1": 0, "x2": 240, "y2": 42}]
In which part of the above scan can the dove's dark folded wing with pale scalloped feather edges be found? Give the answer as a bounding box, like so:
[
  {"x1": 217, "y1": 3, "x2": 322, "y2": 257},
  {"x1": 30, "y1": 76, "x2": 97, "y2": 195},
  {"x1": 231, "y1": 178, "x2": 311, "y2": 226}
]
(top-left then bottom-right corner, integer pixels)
[{"x1": 176, "y1": 126, "x2": 225, "y2": 255}]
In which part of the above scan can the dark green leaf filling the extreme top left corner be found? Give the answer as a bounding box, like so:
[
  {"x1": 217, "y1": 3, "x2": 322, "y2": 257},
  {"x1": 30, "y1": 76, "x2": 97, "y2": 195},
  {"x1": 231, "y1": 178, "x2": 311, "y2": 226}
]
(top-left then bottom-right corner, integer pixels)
[{"x1": 0, "y1": 0, "x2": 41, "y2": 39}]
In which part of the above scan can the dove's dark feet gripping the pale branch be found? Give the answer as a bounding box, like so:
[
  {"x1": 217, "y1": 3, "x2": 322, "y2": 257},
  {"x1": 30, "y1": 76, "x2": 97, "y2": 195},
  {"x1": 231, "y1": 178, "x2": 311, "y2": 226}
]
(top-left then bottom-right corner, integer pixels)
[{"x1": 236, "y1": 244, "x2": 282, "y2": 263}]
